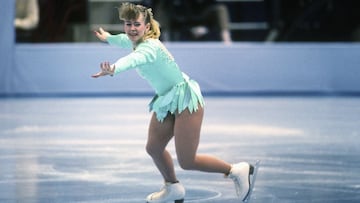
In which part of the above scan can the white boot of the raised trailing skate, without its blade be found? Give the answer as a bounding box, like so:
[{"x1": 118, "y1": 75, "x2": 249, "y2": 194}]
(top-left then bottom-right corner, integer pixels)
[{"x1": 228, "y1": 162, "x2": 254, "y2": 201}]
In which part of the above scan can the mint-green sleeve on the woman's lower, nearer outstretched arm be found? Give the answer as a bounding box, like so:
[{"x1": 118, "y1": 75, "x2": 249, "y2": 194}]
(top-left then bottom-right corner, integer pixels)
[{"x1": 114, "y1": 42, "x2": 156, "y2": 74}]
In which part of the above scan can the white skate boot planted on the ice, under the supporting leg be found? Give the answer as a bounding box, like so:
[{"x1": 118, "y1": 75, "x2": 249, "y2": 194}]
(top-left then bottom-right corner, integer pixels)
[{"x1": 146, "y1": 182, "x2": 185, "y2": 203}]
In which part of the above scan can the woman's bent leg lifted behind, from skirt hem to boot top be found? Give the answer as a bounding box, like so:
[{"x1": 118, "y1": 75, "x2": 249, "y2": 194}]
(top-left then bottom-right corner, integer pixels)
[{"x1": 174, "y1": 107, "x2": 231, "y2": 174}]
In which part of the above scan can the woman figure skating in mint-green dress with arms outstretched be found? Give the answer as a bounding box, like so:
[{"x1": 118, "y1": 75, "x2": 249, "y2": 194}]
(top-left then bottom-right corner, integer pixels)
[{"x1": 92, "y1": 3, "x2": 254, "y2": 203}]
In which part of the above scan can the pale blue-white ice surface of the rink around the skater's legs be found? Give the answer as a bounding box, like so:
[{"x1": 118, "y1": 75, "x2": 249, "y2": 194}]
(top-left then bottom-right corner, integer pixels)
[{"x1": 0, "y1": 96, "x2": 360, "y2": 203}]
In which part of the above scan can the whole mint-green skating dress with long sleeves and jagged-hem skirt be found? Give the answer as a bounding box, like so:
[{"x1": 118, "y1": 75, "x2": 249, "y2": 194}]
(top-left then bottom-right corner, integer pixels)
[{"x1": 107, "y1": 34, "x2": 204, "y2": 122}]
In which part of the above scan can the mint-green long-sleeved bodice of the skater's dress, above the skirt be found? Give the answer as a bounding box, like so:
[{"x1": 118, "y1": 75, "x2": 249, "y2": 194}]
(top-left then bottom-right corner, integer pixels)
[{"x1": 107, "y1": 34, "x2": 184, "y2": 95}]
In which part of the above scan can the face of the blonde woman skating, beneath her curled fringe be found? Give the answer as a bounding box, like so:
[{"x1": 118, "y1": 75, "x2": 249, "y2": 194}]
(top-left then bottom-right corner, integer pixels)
[{"x1": 124, "y1": 15, "x2": 150, "y2": 44}]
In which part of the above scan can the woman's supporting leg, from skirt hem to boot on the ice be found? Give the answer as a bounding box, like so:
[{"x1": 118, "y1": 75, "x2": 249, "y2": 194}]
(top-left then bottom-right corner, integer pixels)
[{"x1": 146, "y1": 113, "x2": 177, "y2": 182}]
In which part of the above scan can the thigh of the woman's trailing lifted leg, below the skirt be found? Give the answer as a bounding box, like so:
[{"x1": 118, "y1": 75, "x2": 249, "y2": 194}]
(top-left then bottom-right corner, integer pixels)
[{"x1": 174, "y1": 106, "x2": 204, "y2": 162}]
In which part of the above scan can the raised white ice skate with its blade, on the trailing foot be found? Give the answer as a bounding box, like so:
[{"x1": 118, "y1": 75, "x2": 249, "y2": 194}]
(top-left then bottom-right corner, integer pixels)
[{"x1": 228, "y1": 161, "x2": 260, "y2": 202}]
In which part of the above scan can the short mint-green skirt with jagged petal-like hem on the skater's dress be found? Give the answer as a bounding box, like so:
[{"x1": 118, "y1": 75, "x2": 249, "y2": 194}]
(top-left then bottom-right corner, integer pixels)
[{"x1": 149, "y1": 74, "x2": 204, "y2": 122}]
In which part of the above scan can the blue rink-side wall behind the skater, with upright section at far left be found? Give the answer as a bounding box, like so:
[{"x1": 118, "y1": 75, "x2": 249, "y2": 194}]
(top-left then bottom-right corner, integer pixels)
[{"x1": 0, "y1": 1, "x2": 360, "y2": 96}]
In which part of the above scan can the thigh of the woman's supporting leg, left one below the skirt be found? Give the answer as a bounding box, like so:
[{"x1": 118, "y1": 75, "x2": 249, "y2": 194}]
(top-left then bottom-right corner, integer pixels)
[{"x1": 147, "y1": 113, "x2": 174, "y2": 150}]
